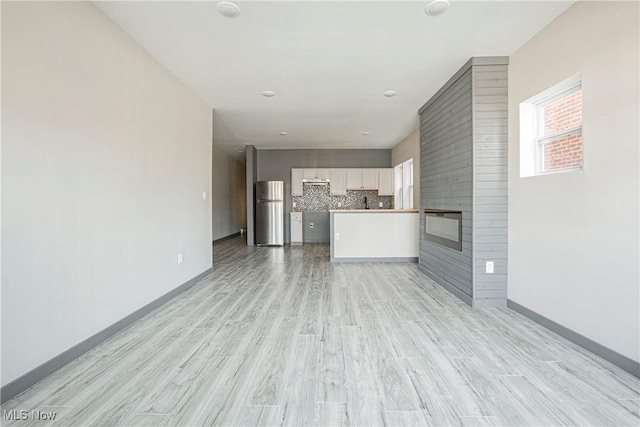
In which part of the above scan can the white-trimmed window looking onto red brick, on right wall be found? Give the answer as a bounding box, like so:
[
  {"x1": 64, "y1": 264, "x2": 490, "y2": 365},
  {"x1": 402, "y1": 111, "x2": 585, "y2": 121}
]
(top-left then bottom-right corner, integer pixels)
[{"x1": 520, "y1": 74, "x2": 583, "y2": 176}]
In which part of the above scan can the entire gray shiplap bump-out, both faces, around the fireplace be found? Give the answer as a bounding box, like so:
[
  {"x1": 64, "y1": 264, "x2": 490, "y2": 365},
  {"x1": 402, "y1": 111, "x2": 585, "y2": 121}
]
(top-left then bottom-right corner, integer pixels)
[{"x1": 419, "y1": 57, "x2": 508, "y2": 306}]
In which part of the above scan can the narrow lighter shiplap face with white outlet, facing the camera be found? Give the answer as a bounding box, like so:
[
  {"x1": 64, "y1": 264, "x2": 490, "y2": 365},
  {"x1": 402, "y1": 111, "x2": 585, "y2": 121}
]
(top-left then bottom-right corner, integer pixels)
[{"x1": 472, "y1": 58, "x2": 508, "y2": 305}]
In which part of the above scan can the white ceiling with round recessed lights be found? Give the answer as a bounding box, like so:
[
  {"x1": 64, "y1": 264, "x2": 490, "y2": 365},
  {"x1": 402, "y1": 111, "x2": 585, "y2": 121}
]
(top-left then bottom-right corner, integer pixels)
[{"x1": 95, "y1": 0, "x2": 573, "y2": 157}]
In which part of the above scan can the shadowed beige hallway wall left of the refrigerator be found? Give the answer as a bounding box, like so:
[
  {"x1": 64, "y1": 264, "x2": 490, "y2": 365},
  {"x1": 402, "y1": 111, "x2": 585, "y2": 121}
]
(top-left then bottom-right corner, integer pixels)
[{"x1": 212, "y1": 146, "x2": 247, "y2": 240}]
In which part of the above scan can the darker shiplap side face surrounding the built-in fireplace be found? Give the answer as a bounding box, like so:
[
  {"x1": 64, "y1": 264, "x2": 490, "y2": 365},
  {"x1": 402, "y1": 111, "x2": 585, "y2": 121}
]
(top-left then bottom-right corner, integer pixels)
[{"x1": 420, "y1": 67, "x2": 473, "y2": 302}]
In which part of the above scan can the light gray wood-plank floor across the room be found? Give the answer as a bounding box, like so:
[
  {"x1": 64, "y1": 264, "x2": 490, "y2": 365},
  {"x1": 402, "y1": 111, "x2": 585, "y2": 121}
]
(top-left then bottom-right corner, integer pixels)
[{"x1": 2, "y1": 238, "x2": 640, "y2": 426}]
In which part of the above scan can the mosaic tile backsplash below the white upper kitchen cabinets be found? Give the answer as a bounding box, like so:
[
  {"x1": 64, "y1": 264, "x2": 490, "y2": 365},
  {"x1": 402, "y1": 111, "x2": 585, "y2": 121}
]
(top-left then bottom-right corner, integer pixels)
[{"x1": 293, "y1": 184, "x2": 393, "y2": 212}]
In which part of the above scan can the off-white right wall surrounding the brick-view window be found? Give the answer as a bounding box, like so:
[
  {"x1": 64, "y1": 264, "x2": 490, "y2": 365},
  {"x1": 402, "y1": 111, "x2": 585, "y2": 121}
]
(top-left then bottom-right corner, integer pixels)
[{"x1": 508, "y1": 1, "x2": 640, "y2": 361}]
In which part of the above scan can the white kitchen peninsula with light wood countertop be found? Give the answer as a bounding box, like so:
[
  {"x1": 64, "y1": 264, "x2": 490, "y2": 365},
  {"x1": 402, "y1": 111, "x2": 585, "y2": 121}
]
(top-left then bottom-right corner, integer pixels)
[{"x1": 329, "y1": 209, "x2": 420, "y2": 262}]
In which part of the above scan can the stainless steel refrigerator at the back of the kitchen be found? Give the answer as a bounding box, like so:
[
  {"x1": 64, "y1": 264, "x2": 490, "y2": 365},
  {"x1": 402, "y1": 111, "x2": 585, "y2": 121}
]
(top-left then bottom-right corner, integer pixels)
[{"x1": 256, "y1": 181, "x2": 284, "y2": 246}]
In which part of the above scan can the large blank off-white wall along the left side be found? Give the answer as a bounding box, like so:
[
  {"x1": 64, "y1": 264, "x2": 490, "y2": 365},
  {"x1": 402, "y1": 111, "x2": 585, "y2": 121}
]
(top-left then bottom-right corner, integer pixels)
[{"x1": 2, "y1": 2, "x2": 212, "y2": 385}]
